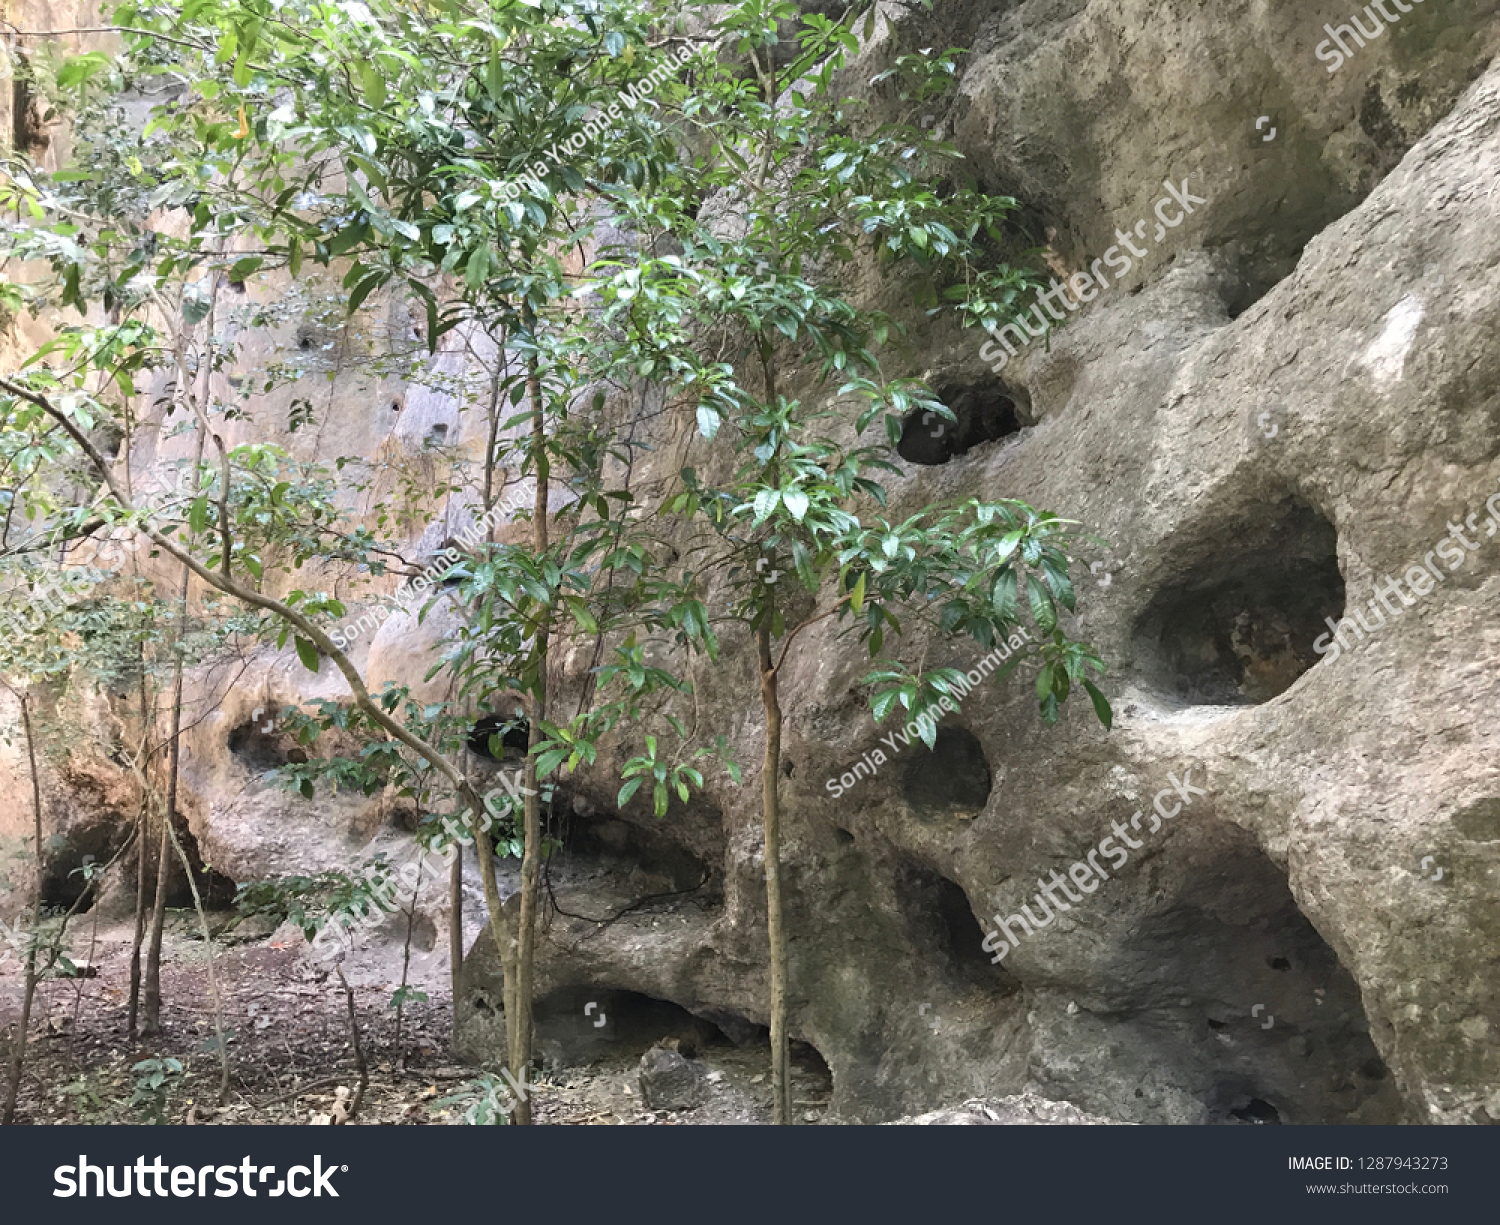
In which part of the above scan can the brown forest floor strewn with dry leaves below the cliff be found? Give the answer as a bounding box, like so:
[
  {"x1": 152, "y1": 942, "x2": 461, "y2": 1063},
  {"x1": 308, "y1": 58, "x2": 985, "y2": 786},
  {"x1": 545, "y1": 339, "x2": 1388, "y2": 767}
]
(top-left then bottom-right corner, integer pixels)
[{"x1": 0, "y1": 912, "x2": 831, "y2": 1125}]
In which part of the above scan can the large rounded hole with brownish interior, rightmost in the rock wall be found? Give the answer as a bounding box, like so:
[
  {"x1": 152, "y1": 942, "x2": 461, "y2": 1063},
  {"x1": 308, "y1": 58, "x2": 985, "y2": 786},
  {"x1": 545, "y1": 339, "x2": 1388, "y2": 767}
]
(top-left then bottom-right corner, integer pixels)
[{"x1": 1136, "y1": 502, "x2": 1344, "y2": 706}]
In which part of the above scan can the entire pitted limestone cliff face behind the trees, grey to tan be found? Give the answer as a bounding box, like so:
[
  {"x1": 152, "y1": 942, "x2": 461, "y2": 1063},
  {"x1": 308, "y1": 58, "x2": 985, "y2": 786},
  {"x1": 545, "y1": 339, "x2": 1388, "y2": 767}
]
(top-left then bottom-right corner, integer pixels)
[{"x1": 11, "y1": 0, "x2": 1500, "y2": 1123}]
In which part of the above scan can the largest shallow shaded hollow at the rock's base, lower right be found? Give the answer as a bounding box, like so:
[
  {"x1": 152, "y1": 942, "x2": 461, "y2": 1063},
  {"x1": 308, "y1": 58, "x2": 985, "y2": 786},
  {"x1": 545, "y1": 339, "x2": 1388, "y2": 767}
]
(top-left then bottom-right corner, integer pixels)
[{"x1": 1116, "y1": 817, "x2": 1403, "y2": 1123}]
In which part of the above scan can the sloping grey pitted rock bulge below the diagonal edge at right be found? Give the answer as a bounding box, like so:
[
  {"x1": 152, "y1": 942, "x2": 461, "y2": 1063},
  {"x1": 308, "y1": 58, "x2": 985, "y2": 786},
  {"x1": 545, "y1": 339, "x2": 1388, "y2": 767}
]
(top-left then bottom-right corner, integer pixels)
[{"x1": 456, "y1": 23, "x2": 1500, "y2": 1123}]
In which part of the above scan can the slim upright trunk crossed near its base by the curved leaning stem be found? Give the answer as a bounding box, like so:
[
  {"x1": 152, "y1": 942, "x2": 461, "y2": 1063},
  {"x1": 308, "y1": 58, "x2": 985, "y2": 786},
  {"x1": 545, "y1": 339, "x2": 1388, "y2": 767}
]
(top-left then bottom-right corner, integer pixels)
[{"x1": 506, "y1": 338, "x2": 551, "y2": 1125}]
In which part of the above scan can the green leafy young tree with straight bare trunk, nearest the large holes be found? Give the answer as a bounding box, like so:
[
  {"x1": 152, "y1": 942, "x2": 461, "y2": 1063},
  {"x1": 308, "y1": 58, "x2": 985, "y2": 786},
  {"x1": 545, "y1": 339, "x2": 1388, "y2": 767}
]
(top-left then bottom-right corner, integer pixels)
[{"x1": 573, "y1": 3, "x2": 1110, "y2": 1123}]
